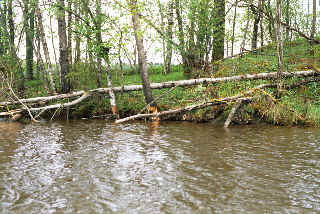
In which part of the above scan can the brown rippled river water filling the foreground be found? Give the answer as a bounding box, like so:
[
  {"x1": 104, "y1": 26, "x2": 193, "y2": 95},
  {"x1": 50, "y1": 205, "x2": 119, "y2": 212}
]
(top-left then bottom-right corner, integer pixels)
[{"x1": 0, "y1": 120, "x2": 320, "y2": 214}]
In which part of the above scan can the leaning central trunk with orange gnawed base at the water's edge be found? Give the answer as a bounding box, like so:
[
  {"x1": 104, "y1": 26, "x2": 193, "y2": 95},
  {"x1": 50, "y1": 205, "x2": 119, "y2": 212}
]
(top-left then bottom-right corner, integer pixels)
[{"x1": 130, "y1": 0, "x2": 157, "y2": 111}]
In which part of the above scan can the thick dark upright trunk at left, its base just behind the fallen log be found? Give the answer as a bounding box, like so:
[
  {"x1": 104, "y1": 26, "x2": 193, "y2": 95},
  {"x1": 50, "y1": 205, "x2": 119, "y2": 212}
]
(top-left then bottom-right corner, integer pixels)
[{"x1": 57, "y1": 0, "x2": 71, "y2": 93}]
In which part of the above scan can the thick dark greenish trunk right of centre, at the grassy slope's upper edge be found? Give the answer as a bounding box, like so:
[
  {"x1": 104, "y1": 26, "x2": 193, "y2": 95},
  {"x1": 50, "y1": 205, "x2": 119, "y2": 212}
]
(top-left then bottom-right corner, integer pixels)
[{"x1": 212, "y1": 0, "x2": 226, "y2": 61}]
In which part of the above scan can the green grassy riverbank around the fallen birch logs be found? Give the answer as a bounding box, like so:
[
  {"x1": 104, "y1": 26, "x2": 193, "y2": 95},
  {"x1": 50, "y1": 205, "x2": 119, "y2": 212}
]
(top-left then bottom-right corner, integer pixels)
[{"x1": 0, "y1": 41, "x2": 320, "y2": 126}]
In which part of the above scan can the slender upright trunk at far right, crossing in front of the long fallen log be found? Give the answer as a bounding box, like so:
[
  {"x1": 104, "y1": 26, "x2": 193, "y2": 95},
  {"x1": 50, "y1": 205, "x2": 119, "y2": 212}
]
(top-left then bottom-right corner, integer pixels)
[{"x1": 276, "y1": 0, "x2": 284, "y2": 96}]
